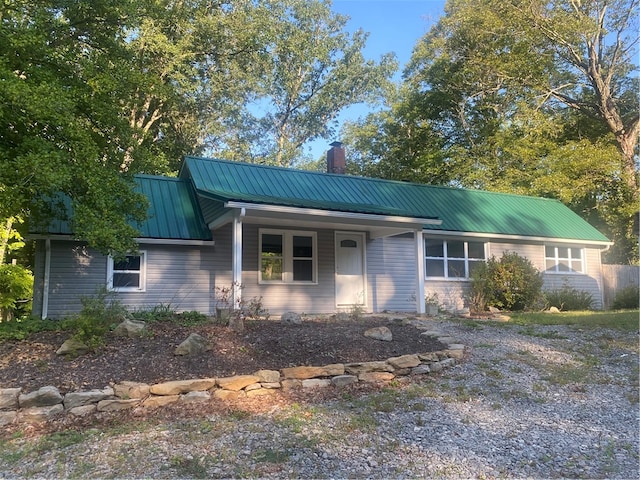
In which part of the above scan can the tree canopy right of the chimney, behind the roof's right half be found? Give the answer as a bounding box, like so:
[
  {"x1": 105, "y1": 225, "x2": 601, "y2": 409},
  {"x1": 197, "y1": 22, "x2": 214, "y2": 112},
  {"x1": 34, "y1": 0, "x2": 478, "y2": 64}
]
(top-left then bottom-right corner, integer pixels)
[{"x1": 346, "y1": 0, "x2": 640, "y2": 263}]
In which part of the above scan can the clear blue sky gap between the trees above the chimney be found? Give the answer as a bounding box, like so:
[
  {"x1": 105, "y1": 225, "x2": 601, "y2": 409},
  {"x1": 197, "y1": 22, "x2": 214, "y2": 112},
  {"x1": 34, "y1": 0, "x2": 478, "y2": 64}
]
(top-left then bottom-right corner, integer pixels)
[{"x1": 305, "y1": 0, "x2": 445, "y2": 159}]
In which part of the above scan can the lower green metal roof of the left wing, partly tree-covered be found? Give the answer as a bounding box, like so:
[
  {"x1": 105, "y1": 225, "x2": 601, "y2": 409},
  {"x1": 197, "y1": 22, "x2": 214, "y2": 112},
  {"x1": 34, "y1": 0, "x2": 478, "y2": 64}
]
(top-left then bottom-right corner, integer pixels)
[{"x1": 34, "y1": 175, "x2": 212, "y2": 240}]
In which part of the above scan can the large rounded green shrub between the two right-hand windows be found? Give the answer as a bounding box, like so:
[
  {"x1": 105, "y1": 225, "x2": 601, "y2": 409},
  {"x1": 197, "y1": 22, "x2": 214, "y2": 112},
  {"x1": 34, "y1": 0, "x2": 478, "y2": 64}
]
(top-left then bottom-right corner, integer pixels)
[{"x1": 469, "y1": 252, "x2": 543, "y2": 311}]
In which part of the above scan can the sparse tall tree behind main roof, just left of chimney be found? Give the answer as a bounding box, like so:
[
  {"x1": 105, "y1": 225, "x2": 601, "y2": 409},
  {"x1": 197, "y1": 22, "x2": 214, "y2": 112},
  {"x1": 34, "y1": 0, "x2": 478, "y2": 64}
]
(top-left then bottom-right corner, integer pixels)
[{"x1": 218, "y1": 0, "x2": 396, "y2": 166}]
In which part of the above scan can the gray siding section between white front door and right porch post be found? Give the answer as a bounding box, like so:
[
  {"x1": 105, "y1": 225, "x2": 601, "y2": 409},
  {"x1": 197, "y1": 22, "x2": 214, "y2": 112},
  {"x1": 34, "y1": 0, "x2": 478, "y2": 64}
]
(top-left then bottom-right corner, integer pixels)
[{"x1": 366, "y1": 234, "x2": 417, "y2": 312}]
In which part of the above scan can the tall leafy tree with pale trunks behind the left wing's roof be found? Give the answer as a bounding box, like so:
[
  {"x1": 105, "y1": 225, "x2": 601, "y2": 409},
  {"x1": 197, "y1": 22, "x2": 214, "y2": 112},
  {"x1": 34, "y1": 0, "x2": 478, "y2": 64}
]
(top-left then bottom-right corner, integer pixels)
[{"x1": 123, "y1": 0, "x2": 274, "y2": 174}]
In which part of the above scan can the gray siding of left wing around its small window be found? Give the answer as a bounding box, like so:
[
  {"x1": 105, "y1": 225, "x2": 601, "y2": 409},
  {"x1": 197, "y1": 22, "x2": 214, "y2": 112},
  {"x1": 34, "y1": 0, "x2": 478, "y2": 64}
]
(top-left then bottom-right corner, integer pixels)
[{"x1": 41, "y1": 241, "x2": 219, "y2": 318}]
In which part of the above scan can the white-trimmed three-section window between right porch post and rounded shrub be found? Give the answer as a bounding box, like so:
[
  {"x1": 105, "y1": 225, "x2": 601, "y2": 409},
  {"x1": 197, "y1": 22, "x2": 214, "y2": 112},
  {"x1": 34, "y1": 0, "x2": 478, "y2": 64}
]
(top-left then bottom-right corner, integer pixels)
[{"x1": 424, "y1": 238, "x2": 486, "y2": 280}]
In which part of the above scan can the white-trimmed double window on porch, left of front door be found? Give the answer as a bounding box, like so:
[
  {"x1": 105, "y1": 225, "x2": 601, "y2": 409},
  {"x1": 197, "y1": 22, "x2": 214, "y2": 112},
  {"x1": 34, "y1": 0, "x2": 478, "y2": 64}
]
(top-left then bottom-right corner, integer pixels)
[{"x1": 259, "y1": 229, "x2": 317, "y2": 283}]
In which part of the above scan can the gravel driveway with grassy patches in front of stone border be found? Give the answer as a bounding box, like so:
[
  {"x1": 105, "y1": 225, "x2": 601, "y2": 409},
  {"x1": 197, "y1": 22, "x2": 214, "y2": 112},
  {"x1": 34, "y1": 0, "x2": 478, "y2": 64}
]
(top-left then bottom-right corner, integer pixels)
[{"x1": 0, "y1": 320, "x2": 640, "y2": 479}]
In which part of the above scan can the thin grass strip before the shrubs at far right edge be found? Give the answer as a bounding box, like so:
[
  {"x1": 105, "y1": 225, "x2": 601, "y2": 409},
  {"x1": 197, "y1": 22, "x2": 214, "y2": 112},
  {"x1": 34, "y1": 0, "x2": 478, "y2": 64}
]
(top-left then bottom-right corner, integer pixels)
[{"x1": 508, "y1": 310, "x2": 640, "y2": 332}]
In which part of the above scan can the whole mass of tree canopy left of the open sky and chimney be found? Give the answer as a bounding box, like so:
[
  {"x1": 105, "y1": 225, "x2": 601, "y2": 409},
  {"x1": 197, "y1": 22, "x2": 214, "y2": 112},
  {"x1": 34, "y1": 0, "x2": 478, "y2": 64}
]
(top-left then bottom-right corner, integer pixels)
[{"x1": 0, "y1": 0, "x2": 395, "y2": 263}]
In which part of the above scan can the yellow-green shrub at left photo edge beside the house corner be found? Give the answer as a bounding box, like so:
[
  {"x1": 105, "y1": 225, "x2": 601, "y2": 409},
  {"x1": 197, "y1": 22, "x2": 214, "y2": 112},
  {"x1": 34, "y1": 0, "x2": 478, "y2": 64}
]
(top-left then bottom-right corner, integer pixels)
[{"x1": 0, "y1": 265, "x2": 33, "y2": 321}]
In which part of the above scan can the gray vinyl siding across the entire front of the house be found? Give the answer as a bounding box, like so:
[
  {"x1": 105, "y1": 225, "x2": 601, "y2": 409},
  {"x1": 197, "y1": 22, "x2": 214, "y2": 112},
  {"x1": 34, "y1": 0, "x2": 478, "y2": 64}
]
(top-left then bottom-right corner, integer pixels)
[{"x1": 33, "y1": 229, "x2": 602, "y2": 318}]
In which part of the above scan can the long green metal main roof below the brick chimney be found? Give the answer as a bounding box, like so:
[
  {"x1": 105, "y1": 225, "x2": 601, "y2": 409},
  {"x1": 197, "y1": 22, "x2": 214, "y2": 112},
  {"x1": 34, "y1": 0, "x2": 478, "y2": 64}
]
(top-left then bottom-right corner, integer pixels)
[{"x1": 180, "y1": 157, "x2": 609, "y2": 242}]
